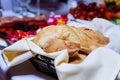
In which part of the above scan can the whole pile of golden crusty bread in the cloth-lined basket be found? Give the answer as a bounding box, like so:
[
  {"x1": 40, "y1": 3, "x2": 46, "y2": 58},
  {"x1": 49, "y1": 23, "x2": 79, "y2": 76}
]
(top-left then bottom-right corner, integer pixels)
[{"x1": 32, "y1": 25, "x2": 109, "y2": 63}]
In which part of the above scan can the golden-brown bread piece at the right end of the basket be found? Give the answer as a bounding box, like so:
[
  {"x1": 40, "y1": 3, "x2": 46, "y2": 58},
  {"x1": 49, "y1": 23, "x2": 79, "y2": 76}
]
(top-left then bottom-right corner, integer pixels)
[{"x1": 70, "y1": 26, "x2": 109, "y2": 54}]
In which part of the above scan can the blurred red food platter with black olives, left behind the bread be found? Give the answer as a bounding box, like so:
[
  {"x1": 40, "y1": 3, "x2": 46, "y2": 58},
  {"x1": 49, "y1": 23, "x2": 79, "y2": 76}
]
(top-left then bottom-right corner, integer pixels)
[{"x1": 0, "y1": 15, "x2": 68, "y2": 42}]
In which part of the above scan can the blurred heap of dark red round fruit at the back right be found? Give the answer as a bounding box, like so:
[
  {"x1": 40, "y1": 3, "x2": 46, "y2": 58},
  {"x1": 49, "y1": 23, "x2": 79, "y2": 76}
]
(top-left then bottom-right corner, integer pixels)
[{"x1": 70, "y1": 2, "x2": 115, "y2": 20}]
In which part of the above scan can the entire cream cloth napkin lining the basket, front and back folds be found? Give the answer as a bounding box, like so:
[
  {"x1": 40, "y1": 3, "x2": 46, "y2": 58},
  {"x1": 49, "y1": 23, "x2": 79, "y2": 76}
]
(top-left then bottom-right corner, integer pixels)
[{"x1": 2, "y1": 18, "x2": 120, "y2": 80}]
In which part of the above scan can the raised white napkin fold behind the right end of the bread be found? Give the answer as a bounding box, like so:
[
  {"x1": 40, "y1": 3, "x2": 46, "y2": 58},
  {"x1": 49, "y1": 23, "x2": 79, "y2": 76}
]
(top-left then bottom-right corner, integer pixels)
[{"x1": 92, "y1": 18, "x2": 120, "y2": 54}]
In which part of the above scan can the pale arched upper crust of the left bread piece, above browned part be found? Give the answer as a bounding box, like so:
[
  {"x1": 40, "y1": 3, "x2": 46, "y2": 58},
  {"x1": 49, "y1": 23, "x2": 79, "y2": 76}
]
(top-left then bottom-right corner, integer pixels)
[{"x1": 33, "y1": 25, "x2": 80, "y2": 47}]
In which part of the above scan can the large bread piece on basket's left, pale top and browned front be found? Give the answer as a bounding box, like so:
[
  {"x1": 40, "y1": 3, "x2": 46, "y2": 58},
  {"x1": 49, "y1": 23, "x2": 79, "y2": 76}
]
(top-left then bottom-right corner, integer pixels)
[{"x1": 32, "y1": 25, "x2": 80, "y2": 57}]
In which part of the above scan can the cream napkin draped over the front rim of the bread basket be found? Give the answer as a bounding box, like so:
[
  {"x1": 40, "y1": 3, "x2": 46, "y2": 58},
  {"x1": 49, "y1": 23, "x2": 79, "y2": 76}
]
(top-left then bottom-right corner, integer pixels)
[{"x1": 3, "y1": 39, "x2": 120, "y2": 80}]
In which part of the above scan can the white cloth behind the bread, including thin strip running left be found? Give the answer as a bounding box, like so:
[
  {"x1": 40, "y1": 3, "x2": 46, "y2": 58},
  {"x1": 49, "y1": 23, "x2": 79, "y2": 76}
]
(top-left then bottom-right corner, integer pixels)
[{"x1": 68, "y1": 18, "x2": 120, "y2": 53}]
